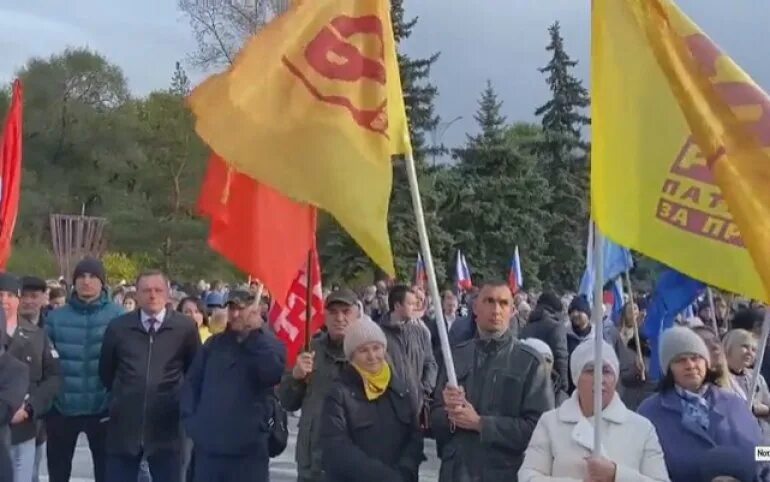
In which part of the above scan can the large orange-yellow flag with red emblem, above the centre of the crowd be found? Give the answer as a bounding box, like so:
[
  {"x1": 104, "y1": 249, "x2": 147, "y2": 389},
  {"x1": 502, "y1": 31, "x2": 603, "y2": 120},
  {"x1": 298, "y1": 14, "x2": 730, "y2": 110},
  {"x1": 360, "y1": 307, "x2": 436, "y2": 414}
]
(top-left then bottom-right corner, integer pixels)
[{"x1": 189, "y1": 0, "x2": 411, "y2": 275}]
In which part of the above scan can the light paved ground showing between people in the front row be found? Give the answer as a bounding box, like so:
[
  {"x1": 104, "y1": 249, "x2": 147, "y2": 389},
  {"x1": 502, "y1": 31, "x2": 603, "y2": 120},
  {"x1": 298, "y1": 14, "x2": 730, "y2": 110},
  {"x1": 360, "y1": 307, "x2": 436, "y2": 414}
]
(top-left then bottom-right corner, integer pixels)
[{"x1": 40, "y1": 418, "x2": 439, "y2": 482}]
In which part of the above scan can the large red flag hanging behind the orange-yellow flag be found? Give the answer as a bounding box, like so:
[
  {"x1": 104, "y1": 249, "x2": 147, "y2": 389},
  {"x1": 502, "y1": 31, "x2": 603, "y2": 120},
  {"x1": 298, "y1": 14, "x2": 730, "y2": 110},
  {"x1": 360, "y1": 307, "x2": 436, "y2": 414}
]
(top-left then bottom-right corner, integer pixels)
[{"x1": 198, "y1": 155, "x2": 316, "y2": 299}]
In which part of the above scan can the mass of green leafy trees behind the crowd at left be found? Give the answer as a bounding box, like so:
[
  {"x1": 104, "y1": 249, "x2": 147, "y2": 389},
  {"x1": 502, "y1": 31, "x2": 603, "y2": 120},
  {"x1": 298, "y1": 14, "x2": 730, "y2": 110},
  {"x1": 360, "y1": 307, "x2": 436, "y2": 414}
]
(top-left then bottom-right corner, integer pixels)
[{"x1": 0, "y1": 49, "x2": 236, "y2": 279}]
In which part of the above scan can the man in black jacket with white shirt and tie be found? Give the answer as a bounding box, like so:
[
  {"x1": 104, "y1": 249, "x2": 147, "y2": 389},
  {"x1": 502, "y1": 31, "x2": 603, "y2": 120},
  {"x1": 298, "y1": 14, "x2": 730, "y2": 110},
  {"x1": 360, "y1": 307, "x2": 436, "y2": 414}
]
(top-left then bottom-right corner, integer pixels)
[{"x1": 99, "y1": 271, "x2": 198, "y2": 482}]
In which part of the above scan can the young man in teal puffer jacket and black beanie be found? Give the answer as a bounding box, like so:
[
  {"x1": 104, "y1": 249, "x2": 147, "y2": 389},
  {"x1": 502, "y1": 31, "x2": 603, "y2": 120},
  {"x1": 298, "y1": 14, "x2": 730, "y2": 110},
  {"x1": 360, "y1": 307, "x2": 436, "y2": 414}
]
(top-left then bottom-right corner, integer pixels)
[{"x1": 46, "y1": 258, "x2": 124, "y2": 482}]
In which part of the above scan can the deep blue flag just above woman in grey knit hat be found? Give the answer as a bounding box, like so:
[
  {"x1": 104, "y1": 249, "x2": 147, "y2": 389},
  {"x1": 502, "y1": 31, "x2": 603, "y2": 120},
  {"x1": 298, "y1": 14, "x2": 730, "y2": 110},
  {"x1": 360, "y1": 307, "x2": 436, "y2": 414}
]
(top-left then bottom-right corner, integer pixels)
[{"x1": 642, "y1": 268, "x2": 706, "y2": 380}]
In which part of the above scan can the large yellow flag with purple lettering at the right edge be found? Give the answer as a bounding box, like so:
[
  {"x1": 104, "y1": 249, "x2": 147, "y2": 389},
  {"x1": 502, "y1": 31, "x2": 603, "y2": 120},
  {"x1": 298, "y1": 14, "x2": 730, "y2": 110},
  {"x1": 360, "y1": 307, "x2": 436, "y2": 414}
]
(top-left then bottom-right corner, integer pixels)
[{"x1": 591, "y1": 0, "x2": 770, "y2": 300}]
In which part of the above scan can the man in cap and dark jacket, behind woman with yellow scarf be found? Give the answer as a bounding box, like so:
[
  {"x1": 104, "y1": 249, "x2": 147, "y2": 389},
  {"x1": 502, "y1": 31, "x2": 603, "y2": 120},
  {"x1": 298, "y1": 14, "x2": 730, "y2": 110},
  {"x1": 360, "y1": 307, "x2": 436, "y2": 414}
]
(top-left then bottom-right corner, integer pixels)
[{"x1": 278, "y1": 288, "x2": 360, "y2": 482}]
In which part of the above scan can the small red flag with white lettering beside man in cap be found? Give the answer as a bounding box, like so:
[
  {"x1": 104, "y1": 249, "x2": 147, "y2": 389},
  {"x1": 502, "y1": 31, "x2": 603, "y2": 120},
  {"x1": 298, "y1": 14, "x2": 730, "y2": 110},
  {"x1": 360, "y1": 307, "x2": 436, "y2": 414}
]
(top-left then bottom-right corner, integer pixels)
[{"x1": 267, "y1": 248, "x2": 324, "y2": 367}]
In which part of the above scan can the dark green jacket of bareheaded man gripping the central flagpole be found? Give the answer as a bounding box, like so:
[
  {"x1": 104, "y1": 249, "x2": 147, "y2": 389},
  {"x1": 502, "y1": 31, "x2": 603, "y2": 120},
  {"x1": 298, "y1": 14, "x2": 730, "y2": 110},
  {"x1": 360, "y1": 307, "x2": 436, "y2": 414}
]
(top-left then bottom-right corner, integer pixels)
[{"x1": 431, "y1": 332, "x2": 554, "y2": 482}]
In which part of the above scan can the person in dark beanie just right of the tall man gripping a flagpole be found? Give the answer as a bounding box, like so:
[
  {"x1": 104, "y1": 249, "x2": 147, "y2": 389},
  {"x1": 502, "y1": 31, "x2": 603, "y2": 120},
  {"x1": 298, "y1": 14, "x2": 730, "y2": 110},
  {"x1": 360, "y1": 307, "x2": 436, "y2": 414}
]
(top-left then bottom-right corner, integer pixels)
[{"x1": 519, "y1": 291, "x2": 570, "y2": 392}]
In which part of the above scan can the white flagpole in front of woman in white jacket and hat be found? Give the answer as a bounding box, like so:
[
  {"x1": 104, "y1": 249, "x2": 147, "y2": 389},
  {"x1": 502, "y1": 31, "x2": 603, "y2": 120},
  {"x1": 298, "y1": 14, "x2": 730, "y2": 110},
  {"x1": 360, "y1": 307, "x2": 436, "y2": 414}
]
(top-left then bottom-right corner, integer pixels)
[{"x1": 592, "y1": 224, "x2": 604, "y2": 456}]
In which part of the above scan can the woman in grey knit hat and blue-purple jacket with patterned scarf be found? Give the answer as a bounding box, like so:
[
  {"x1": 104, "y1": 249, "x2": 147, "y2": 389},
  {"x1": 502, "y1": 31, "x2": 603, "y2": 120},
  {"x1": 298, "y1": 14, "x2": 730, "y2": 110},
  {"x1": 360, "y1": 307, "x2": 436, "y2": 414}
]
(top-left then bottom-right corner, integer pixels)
[{"x1": 639, "y1": 327, "x2": 761, "y2": 482}]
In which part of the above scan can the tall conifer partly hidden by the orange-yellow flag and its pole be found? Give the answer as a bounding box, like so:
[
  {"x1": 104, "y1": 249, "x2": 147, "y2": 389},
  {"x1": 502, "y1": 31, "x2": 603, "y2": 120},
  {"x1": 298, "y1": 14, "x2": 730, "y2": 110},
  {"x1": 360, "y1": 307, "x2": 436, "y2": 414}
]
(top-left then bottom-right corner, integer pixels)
[{"x1": 319, "y1": 0, "x2": 451, "y2": 281}]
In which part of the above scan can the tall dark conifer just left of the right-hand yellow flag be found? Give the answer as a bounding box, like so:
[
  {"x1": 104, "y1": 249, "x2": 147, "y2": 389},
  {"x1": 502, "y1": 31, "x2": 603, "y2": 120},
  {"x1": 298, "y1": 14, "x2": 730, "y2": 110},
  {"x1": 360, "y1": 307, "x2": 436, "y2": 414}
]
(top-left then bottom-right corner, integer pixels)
[{"x1": 535, "y1": 22, "x2": 590, "y2": 290}]
